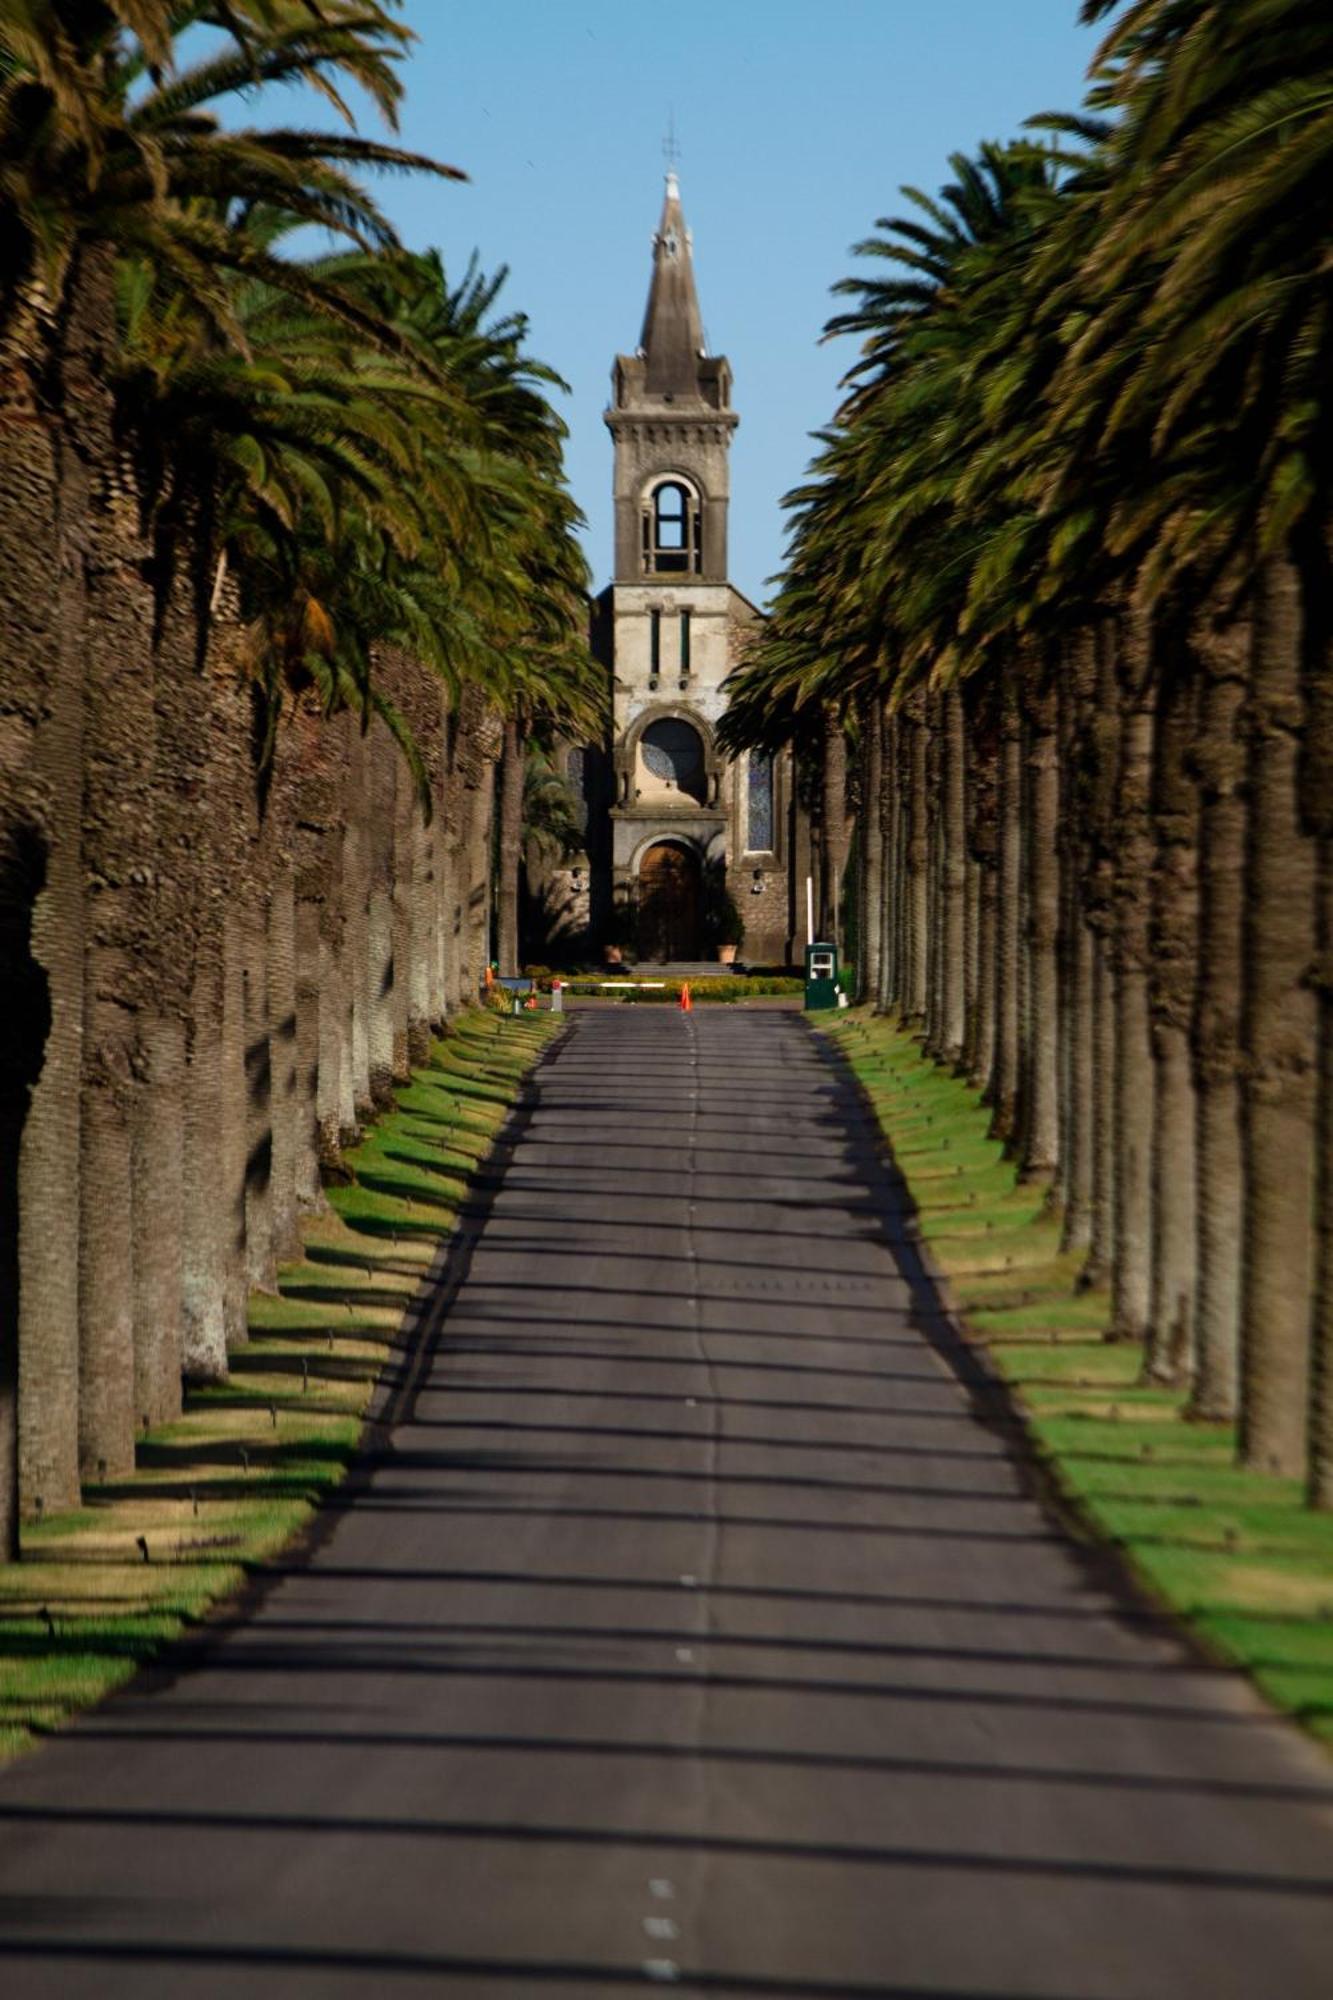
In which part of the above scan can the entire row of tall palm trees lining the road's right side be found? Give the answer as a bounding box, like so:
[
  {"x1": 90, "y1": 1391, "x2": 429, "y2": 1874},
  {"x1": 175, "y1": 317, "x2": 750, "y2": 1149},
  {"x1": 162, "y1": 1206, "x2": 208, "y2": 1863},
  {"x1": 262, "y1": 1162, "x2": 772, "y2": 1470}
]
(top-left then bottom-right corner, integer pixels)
[{"x1": 729, "y1": 0, "x2": 1333, "y2": 1506}]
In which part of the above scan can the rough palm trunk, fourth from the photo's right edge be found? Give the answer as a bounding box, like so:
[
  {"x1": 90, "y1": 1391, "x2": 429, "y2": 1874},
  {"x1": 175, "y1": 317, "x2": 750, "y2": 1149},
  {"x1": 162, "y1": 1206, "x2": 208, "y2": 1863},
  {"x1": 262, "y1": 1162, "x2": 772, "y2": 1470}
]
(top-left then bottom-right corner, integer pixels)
[{"x1": 1145, "y1": 644, "x2": 1199, "y2": 1386}]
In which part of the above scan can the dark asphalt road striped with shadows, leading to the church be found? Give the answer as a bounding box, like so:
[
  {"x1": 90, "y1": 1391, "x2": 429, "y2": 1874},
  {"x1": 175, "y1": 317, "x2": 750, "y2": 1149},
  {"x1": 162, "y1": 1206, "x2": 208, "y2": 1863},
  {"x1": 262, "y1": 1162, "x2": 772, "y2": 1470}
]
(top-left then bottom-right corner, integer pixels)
[{"x1": 0, "y1": 1008, "x2": 1333, "y2": 2000}]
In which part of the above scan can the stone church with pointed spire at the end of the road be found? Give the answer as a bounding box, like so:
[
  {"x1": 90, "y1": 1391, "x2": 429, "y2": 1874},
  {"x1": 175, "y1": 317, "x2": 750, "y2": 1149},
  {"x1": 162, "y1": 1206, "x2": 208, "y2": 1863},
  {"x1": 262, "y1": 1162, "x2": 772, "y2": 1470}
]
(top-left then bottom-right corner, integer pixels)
[{"x1": 570, "y1": 172, "x2": 805, "y2": 964}]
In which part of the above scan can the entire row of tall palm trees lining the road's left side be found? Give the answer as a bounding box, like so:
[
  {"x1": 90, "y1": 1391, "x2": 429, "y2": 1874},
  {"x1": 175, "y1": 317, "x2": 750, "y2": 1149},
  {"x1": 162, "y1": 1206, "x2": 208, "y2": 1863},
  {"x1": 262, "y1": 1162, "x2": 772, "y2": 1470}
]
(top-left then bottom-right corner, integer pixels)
[{"x1": 0, "y1": 0, "x2": 600, "y2": 1554}]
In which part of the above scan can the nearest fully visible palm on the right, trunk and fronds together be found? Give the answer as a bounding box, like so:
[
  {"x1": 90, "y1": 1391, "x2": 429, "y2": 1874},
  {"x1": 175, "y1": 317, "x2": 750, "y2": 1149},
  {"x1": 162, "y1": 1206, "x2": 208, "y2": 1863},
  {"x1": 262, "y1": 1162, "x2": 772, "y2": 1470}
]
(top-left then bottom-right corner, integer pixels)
[{"x1": 1085, "y1": 0, "x2": 1333, "y2": 1484}]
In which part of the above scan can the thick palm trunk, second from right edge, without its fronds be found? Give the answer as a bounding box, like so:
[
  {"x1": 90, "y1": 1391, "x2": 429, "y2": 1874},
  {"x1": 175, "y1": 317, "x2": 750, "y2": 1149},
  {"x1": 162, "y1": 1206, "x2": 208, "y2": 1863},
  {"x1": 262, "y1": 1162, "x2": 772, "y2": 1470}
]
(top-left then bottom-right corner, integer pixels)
[{"x1": 1241, "y1": 560, "x2": 1315, "y2": 1478}]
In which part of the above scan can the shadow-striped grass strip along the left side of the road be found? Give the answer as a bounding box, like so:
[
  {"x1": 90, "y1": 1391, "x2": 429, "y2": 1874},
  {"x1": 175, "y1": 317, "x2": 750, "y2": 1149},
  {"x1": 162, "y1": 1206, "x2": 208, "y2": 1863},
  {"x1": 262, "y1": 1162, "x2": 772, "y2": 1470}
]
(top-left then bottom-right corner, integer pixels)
[{"x1": 0, "y1": 1012, "x2": 560, "y2": 1760}]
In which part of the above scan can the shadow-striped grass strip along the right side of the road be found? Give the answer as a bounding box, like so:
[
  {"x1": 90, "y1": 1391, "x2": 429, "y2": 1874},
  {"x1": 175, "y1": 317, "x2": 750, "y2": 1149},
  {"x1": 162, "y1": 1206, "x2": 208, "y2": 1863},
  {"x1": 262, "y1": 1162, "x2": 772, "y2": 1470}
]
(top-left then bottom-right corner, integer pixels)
[{"x1": 825, "y1": 1012, "x2": 1333, "y2": 1742}]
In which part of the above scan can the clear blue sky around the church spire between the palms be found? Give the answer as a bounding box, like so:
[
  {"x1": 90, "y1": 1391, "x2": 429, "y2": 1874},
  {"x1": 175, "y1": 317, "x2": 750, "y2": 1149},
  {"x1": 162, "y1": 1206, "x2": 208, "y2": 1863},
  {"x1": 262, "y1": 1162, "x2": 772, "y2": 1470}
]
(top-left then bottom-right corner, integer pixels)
[{"x1": 324, "y1": 0, "x2": 1097, "y2": 600}]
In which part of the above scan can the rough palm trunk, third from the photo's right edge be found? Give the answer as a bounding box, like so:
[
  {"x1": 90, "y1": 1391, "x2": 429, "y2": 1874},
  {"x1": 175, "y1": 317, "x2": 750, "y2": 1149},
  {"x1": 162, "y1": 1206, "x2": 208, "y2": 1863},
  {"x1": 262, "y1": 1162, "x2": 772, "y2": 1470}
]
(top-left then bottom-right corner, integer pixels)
[{"x1": 1189, "y1": 614, "x2": 1253, "y2": 1422}]
